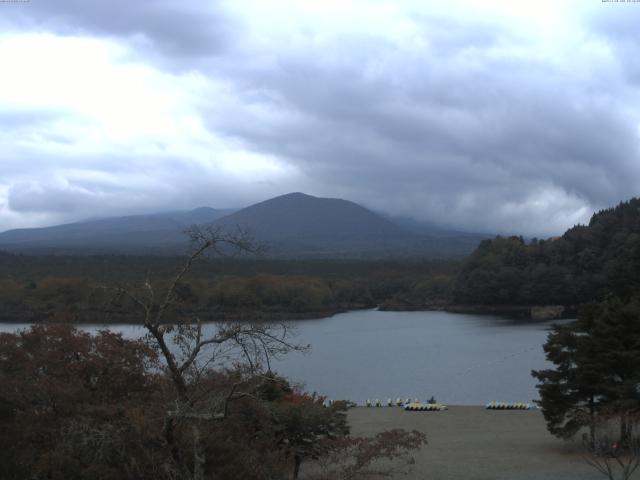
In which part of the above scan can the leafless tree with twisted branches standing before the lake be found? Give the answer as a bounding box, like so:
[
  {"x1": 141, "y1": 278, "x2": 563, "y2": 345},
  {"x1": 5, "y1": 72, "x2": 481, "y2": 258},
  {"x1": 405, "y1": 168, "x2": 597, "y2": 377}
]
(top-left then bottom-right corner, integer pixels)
[{"x1": 112, "y1": 226, "x2": 308, "y2": 480}]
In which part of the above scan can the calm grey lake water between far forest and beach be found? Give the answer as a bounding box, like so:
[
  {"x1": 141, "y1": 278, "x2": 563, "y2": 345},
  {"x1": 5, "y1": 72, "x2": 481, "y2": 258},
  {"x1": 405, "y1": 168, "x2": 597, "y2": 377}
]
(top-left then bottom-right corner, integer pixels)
[{"x1": 0, "y1": 310, "x2": 551, "y2": 405}]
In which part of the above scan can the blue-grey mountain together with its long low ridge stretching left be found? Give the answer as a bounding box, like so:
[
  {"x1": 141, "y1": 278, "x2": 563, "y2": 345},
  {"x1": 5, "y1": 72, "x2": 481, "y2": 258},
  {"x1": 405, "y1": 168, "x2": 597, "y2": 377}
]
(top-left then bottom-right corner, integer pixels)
[{"x1": 0, "y1": 193, "x2": 484, "y2": 258}]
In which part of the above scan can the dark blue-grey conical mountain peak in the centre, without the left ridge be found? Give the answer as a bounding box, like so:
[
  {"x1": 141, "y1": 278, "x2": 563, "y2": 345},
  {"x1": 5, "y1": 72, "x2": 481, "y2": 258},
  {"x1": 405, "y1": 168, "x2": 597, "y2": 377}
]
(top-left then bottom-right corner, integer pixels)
[{"x1": 210, "y1": 192, "x2": 484, "y2": 258}]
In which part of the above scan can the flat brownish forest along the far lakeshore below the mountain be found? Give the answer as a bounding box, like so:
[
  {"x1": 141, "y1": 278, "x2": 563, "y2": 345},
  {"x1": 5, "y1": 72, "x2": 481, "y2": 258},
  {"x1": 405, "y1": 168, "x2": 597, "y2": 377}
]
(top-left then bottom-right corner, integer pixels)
[{"x1": 0, "y1": 253, "x2": 458, "y2": 322}]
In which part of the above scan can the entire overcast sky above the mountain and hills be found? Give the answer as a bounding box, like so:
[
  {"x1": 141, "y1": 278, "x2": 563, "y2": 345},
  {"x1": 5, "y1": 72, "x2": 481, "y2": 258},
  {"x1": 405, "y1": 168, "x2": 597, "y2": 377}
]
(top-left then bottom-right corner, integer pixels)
[{"x1": 0, "y1": 0, "x2": 640, "y2": 236}]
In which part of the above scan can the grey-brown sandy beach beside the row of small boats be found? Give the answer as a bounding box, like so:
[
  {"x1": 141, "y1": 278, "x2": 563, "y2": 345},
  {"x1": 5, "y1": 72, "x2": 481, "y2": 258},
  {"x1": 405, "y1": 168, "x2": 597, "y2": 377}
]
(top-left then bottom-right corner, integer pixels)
[{"x1": 349, "y1": 406, "x2": 616, "y2": 480}]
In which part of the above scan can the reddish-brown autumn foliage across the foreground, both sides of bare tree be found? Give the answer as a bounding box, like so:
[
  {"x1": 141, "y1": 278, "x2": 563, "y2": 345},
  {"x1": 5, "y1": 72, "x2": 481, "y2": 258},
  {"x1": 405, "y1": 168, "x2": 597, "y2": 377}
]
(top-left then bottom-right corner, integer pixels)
[{"x1": 0, "y1": 324, "x2": 424, "y2": 480}]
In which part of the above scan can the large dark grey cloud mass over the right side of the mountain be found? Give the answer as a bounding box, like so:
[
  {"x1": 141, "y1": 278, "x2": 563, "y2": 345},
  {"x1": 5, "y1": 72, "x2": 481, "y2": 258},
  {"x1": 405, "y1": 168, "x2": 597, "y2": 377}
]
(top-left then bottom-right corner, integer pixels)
[{"x1": 204, "y1": 14, "x2": 640, "y2": 233}]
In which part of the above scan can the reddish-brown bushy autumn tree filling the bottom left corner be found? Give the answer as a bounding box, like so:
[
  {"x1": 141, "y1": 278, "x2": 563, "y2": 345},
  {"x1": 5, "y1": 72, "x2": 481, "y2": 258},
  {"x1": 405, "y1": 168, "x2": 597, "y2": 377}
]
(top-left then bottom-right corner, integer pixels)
[{"x1": 0, "y1": 325, "x2": 168, "y2": 479}]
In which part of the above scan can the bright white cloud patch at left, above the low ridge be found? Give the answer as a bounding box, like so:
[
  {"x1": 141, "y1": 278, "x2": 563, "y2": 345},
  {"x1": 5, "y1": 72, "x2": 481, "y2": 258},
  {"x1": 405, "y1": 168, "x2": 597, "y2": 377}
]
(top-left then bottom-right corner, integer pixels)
[{"x1": 0, "y1": 32, "x2": 296, "y2": 229}]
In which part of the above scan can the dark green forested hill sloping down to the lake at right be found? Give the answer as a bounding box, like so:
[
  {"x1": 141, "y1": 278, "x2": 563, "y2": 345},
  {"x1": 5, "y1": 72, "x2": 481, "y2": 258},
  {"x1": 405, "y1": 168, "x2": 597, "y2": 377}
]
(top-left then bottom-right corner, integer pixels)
[{"x1": 452, "y1": 198, "x2": 640, "y2": 306}]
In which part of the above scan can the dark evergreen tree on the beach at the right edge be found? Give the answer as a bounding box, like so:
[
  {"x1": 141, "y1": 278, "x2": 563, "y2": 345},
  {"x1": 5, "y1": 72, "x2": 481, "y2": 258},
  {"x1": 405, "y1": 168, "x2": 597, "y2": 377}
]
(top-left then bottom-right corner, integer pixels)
[{"x1": 532, "y1": 297, "x2": 640, "y2": 442}]
